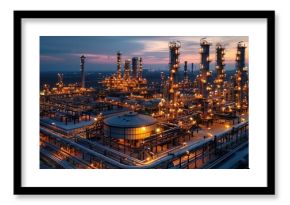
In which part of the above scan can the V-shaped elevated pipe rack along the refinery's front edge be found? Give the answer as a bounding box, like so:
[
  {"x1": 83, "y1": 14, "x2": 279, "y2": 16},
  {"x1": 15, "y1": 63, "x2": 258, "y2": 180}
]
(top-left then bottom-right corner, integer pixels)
[{"x1": 40, "y1": 122, "x2": 248, "y2": 169}]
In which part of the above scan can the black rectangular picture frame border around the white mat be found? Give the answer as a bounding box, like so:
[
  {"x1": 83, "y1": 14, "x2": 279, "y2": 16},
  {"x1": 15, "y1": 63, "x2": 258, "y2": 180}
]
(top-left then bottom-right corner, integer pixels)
[{"x1": 14, "y1": 11, "x2": 275, "y2": 195}]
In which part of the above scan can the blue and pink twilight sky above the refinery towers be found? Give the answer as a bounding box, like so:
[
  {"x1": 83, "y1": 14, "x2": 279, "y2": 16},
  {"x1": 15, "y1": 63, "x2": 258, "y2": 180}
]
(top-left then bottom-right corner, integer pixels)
[{"x1": 40, "y1": 36, "x2": 248, "y2": 71}]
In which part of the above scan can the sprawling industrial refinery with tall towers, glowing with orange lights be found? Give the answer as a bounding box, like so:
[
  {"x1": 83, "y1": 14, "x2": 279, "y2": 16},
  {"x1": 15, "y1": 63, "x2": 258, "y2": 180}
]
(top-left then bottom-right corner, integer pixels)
[{"x1": 40, "y1": 38, "x2": 248, "y2": 169}]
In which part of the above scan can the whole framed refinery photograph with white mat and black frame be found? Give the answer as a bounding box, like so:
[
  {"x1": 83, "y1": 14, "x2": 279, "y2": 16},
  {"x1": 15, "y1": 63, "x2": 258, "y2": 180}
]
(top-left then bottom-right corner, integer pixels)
[{"x1": 14, "y1": 11, "x2": 275, "y2": 195}]
